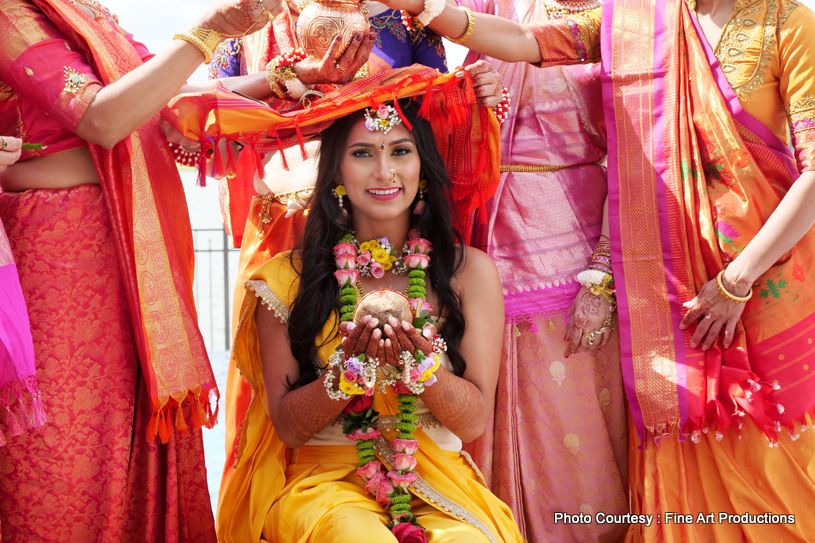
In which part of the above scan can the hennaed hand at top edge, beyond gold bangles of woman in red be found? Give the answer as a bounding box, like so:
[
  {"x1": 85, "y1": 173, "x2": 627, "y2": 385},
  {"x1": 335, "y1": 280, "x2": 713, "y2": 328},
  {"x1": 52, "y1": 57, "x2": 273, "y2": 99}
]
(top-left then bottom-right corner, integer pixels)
[{"x1": 195, "y1": 0, "x2": 280, "y2": 38}]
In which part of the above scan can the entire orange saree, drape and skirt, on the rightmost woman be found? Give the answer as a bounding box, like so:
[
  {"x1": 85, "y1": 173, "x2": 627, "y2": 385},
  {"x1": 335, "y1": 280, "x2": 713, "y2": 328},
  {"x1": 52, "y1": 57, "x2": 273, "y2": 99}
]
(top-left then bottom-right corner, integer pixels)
[{"x1": 601, "y1": 0, "x2": 815, "y2": 542}]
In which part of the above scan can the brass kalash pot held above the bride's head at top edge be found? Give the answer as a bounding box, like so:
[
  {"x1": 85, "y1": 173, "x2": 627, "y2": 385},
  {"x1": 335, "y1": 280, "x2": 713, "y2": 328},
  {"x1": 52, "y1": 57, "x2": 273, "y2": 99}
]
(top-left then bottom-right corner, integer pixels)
[{"x1": 297, "y1": 0, "x2": 370, "y2": 60}]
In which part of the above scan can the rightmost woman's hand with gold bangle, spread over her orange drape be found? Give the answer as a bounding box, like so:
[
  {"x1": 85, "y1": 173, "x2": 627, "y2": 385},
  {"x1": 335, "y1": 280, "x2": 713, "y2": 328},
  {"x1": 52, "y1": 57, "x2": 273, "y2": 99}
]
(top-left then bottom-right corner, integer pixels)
[{"x1": 679, "y1": 278, "x2": 745, "y2": 351}]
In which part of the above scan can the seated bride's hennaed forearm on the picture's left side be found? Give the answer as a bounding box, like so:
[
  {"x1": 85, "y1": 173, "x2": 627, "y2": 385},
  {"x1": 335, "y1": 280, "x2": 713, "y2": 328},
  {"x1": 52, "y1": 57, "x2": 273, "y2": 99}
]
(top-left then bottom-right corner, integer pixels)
[{"x1": 274, "y1": 370, "x2": 350, "y2": 449}]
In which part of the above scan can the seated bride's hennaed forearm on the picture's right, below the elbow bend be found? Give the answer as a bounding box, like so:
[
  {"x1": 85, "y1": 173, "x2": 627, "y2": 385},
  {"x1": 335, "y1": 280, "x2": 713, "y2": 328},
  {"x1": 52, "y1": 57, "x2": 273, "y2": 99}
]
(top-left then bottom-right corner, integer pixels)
[{"x1": 420, "y1": 367, "x2": 489, "y2": 443}]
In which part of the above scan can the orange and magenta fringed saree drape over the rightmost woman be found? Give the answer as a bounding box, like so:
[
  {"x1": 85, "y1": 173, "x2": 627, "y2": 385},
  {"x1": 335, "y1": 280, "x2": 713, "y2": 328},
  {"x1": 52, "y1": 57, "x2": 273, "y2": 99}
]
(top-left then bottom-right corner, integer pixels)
[{"x1": 601, "y1": 0, "x2": 815, "y2": 444}]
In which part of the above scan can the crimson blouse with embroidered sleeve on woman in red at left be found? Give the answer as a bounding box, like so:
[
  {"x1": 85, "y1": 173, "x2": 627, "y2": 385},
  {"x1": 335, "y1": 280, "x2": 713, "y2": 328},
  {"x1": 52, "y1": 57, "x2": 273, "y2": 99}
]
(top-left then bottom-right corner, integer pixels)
[{"x1": 0, "y1": 0, "x2": 152, "y2": 160}]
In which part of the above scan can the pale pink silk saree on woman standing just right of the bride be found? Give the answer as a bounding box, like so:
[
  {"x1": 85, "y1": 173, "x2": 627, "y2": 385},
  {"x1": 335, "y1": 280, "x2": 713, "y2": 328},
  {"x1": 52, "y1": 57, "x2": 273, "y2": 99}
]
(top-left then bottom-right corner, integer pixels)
[{"x1": 459, "y1": 0, "x2": 628, "y2": 543}]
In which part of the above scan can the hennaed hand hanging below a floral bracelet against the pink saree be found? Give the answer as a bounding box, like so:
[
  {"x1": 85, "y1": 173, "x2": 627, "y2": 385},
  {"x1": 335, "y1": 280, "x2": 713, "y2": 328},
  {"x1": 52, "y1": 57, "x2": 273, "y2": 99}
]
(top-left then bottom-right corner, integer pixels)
[{"x1": 563, "y1": 287, "x2": 613, "y2": 358}]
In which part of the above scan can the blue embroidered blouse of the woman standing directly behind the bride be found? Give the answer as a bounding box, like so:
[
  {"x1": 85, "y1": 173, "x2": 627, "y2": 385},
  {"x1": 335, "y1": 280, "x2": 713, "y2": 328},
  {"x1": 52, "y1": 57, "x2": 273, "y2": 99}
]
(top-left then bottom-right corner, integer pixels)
[{"x1": 210, "y1": 9, "x2": 447, "y2": 79}]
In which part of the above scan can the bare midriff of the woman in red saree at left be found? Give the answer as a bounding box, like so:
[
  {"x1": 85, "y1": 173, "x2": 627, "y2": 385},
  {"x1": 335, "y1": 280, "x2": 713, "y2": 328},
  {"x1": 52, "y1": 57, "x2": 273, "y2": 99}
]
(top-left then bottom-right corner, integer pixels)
[{"x1": 0, "y1": 147, "x2": 99, "y2": 192}]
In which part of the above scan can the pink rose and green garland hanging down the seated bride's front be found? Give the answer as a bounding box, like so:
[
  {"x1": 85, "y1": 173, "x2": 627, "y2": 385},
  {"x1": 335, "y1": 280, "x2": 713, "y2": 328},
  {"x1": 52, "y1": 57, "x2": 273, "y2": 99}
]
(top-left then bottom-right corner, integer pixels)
[{"x1": 324, "y1": 229, "x2": 447, "y2": 542}]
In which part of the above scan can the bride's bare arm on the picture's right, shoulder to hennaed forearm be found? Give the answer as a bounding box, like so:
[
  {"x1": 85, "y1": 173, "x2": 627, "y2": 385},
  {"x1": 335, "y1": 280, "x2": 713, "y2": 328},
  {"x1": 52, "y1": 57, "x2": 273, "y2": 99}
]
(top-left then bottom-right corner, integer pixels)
[{"x1": 421, "y1": 247, "x2": 504, "y2": 442}]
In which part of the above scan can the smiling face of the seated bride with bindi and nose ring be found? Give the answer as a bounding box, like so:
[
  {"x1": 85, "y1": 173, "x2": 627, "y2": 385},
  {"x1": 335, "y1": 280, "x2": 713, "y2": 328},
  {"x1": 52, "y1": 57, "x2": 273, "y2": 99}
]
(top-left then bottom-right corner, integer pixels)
[{"x1": 339, "y1": 118, "x2": 421, "y2": 220}]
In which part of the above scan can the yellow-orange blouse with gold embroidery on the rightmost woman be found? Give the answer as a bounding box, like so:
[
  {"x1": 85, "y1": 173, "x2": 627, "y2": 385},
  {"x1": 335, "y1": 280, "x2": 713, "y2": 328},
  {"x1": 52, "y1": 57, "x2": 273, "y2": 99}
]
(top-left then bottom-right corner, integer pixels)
[{"x1": 531, "y1": 0, "x2": 815, "y2": 171}]
